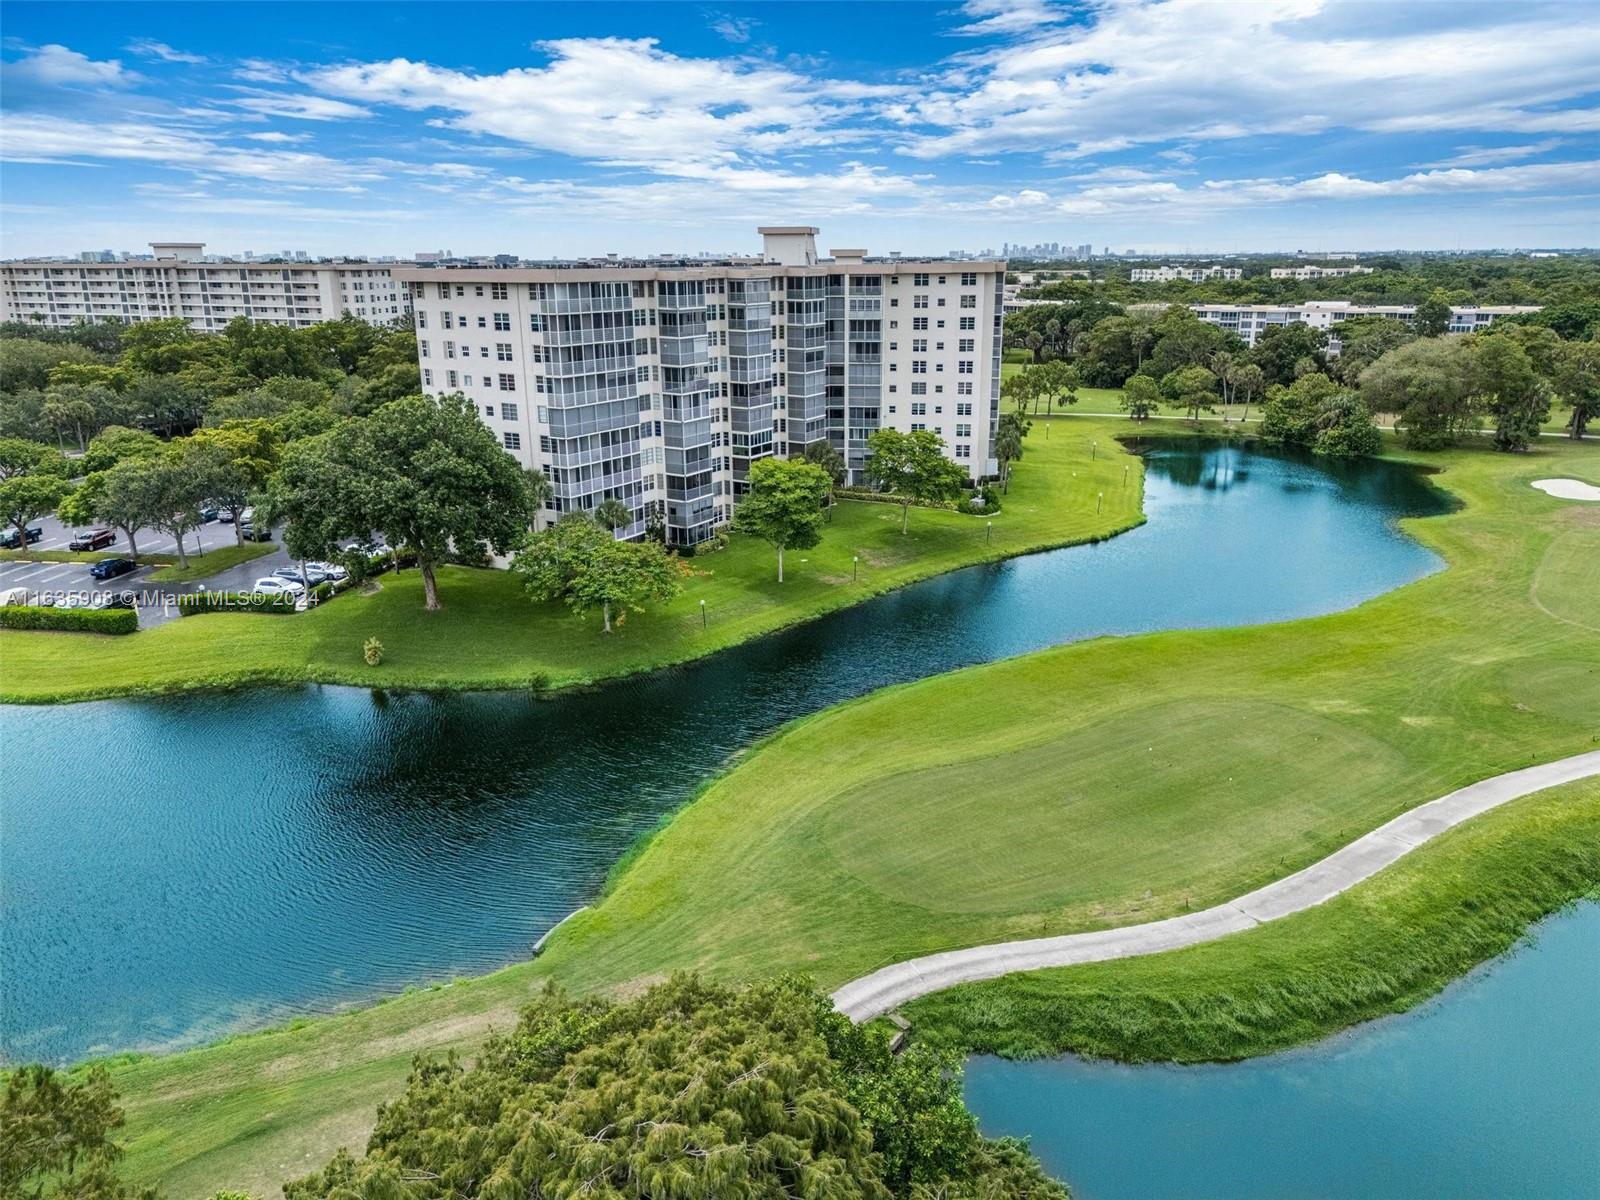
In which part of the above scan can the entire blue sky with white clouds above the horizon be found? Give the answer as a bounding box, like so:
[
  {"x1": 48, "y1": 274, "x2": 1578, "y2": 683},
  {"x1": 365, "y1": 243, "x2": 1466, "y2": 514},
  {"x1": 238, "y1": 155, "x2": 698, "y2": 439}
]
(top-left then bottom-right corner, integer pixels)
[{"x1": 0, "y1": 0, "x2": 1600, "y2": 258}]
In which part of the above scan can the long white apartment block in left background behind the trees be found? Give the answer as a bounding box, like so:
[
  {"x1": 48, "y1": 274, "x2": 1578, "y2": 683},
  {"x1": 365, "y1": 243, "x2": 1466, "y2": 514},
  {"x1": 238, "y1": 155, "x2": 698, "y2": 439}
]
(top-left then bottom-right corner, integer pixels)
[{"x1": 0, "y1": 242, "x2": 406, "y2": 333}]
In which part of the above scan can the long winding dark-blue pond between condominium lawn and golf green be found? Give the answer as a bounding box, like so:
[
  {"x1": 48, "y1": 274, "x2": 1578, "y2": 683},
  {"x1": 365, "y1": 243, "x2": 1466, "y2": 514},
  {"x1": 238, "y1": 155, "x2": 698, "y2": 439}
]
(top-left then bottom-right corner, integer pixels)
[{"x1": 0, "y1": 442, "x2": 1442, "y2": 1061}]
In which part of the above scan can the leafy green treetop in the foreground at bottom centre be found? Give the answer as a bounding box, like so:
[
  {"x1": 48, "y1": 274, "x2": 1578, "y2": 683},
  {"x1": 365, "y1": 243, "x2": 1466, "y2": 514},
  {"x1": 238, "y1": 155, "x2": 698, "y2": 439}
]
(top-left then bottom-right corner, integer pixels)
[{"x1": 283, "y1": 976, "x2": 1066, "y2": 1200}]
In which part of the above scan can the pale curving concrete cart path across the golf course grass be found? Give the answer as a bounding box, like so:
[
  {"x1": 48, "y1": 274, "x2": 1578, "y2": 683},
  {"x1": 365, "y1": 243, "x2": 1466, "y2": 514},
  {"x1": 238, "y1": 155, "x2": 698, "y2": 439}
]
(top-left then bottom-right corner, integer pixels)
[{"x1": 834, "y1": 750, "x2": 1600, "y2": 1021}]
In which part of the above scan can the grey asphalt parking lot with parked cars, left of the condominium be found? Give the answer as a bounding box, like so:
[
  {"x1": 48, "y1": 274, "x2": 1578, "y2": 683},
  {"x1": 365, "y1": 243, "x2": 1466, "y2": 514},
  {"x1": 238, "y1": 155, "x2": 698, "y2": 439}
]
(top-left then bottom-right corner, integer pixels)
[{"x1": 0, "y1": 517, "x2": 290, "y2": 629}]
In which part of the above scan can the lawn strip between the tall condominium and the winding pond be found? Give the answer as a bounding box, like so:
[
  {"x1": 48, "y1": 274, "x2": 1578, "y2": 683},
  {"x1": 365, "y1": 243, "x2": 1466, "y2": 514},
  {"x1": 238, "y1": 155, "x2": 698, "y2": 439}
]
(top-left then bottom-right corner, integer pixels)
[{"x1": 0, "y1": 424, "x2": 1142, "y2": 702}]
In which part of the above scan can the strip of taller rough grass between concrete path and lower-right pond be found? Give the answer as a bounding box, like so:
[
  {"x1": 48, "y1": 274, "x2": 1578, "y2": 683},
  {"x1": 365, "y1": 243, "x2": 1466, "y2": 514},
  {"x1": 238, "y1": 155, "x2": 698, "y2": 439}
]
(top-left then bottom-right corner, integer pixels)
[{"x1": 906, "y1": 779, "x2": 1600, "y2": 1062}]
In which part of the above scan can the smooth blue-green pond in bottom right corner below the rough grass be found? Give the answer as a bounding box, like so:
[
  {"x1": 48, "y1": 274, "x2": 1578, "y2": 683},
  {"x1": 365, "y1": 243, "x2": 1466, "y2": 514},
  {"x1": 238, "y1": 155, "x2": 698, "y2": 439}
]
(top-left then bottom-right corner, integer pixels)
[{"x1": 966, "y1": 904, "x2": 1600, "y2": 1200}]
